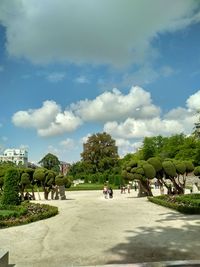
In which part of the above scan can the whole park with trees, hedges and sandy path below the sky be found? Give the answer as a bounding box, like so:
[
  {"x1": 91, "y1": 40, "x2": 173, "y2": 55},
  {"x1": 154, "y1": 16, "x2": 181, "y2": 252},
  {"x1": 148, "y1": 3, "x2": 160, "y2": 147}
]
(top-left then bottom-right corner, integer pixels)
[{"x1": 0, "y1": 133, "x2": 200, "y2": 267}]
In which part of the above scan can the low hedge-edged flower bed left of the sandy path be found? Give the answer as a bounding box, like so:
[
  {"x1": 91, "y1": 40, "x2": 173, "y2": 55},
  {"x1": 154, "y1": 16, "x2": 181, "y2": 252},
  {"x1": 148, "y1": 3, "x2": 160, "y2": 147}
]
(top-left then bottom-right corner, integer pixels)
[{"x1": 0, "y1": 203, "x2": 58, "y2": 228}]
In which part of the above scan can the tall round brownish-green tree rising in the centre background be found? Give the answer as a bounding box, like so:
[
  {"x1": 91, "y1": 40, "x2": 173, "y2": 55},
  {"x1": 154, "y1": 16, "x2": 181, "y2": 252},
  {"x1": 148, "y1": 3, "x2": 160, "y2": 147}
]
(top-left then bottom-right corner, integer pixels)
[{"x1": 81, "y1": 132, "x2": 119, "y2": 173}]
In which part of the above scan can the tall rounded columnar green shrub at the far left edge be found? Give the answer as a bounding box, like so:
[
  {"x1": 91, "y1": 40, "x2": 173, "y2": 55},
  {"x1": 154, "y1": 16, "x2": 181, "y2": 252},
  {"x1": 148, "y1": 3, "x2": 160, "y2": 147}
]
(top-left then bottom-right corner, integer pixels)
[{"x1": 1, "y1": 167, "x2": 20, "y2": 205}]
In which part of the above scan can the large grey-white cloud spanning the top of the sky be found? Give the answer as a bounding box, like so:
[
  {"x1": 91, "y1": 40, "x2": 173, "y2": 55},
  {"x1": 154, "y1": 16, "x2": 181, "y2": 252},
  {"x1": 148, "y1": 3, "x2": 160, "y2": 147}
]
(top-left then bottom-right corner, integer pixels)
[{"x1": 0, "y1": 0, "x2": 199, "y2": 66}]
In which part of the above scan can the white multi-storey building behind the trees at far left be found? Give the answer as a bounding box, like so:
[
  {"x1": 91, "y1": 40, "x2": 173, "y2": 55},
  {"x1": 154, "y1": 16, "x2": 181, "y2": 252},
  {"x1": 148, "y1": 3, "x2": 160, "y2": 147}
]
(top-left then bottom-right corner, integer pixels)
[{"x1": 0, "y1": 148, "x2": 28, "y2": 167}]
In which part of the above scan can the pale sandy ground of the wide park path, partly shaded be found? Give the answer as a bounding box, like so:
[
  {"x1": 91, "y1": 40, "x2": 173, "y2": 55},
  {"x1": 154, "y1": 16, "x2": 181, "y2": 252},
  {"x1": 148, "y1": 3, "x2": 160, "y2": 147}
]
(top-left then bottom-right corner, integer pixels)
[{"x1": 0, "y1": 189, "x2": 200, "y2": 267}]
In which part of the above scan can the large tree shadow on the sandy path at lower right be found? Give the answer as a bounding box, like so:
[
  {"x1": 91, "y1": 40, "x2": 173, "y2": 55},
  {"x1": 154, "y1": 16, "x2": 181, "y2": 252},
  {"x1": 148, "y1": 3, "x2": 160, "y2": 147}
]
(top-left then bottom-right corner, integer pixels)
[{"x1": 107, "y1": 223, "x2": 200, "y2": 264}]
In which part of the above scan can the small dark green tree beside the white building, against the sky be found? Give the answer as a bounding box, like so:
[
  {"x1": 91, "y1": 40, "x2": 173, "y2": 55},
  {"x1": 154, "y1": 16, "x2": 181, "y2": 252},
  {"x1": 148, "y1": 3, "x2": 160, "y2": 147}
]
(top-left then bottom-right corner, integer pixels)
[{"x1": 38, "y1": 153, "x2": 60, "y2": 173}]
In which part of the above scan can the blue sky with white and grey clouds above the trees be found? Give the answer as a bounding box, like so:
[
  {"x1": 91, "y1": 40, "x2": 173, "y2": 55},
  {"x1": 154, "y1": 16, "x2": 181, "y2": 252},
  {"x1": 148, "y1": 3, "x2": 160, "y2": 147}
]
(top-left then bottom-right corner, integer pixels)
[{"x1": 0, "y1": 0, "x2": 200, "y2": 163}]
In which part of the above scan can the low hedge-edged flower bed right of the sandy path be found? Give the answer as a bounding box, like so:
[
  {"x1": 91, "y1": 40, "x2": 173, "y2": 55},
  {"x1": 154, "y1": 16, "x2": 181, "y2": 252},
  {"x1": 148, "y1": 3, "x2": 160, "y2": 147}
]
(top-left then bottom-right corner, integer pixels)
[{"x1": 148, "y1": 194, "x2": 200, "y2": 214}]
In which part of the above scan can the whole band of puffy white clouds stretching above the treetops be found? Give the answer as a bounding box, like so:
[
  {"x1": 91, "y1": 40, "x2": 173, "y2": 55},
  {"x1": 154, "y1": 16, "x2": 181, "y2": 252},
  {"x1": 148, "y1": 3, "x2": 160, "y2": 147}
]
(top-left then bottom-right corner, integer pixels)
[{"x1": 12, "y1": 86, "x2": 200, "y2": 143}]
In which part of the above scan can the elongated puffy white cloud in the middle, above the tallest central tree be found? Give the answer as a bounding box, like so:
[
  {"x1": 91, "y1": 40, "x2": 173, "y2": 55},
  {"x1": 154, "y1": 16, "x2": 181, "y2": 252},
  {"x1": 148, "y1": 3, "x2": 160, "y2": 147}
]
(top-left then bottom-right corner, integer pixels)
[{"x1": 71, "y1": 86, "x2": 160, "y2": 122}]
